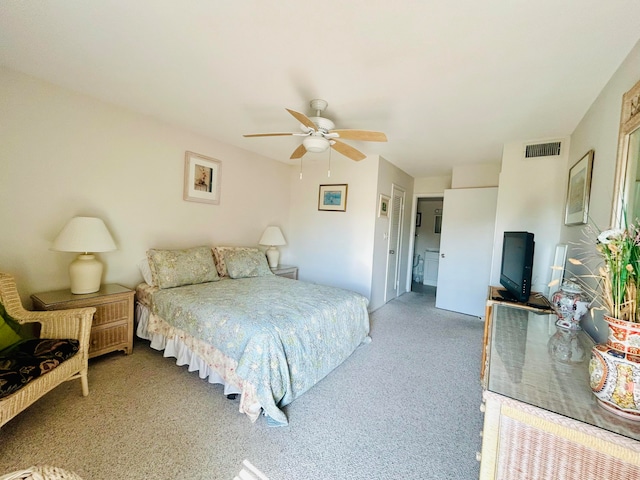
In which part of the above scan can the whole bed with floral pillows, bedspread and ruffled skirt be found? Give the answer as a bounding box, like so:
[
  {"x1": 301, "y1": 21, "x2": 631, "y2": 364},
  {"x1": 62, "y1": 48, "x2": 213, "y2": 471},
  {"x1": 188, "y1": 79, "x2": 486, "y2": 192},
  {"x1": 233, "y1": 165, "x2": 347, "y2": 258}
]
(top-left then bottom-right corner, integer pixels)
[{"x1": 136, "y1": 247, "x2": 370, "y2": 426}]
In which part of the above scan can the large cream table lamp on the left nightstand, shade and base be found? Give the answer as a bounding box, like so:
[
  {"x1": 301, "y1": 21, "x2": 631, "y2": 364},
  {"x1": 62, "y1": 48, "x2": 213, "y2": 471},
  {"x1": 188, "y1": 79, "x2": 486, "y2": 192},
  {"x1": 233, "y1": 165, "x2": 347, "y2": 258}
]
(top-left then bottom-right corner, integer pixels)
[{"x1": 51, "y1": 217, "x2": 116, "y2": 294}]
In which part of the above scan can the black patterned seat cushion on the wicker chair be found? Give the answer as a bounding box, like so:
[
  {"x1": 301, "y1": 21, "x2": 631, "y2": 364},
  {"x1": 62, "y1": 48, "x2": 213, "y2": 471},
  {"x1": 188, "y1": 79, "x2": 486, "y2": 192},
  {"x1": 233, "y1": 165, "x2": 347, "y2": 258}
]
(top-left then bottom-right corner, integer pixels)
[{"x1": 0, "y1": 338, "x2": 80, "y2": 398}]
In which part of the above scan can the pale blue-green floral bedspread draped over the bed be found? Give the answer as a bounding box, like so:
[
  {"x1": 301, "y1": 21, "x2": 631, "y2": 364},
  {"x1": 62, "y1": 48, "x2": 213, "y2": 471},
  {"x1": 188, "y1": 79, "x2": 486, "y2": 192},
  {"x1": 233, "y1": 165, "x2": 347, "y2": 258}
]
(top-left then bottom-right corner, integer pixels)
[{"x1": 152, "y1": 275, "x2": 369, "y2": 425}]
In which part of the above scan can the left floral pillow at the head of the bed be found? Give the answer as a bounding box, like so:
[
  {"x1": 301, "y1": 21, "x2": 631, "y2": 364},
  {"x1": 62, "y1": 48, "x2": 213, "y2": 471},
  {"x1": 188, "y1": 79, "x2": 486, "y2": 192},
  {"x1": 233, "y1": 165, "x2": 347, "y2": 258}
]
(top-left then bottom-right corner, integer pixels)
[{"x1": 147, "y1": 247, "x2": 220, "y2": 288}]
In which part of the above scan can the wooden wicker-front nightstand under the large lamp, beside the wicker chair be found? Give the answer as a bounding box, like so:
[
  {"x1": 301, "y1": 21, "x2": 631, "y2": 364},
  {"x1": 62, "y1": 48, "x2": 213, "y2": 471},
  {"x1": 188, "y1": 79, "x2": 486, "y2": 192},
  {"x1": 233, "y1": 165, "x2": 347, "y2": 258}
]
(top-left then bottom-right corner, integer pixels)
[{"x1": 31, "y1": 284, "x2": 135, "y2": 358}]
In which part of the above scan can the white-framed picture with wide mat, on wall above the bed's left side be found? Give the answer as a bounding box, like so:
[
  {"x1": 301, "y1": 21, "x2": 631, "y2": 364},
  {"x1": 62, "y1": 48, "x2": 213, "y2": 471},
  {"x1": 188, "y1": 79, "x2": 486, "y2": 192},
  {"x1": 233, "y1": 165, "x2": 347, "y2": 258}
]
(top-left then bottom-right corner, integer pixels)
[{"x1": 183, "y1": 152, "x2": 222, "y2": 205}]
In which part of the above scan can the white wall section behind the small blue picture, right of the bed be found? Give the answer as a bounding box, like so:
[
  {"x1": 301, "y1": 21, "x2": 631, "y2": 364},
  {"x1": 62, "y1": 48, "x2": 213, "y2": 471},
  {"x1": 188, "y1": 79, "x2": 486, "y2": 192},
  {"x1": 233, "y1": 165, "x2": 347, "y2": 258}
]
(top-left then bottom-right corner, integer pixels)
[{"x1": 285, "y1": 153, "x2": 378, "y2": 297}]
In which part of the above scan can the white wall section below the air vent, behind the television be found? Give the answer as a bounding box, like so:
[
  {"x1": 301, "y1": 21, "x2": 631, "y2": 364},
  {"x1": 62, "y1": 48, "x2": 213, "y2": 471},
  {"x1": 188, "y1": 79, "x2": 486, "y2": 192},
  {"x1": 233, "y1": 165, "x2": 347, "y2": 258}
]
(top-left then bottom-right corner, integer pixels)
[{"x1": 491, "y1": 138, "x2": 570, "y2": 293}]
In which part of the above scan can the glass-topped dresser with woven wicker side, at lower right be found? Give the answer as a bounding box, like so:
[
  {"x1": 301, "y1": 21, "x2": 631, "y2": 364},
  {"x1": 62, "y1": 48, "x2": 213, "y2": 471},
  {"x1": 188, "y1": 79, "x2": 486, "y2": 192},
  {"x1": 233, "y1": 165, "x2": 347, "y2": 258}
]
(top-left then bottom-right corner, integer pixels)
[{"x1": 478, "y1": 300, "x2": 640, "y2": 480}]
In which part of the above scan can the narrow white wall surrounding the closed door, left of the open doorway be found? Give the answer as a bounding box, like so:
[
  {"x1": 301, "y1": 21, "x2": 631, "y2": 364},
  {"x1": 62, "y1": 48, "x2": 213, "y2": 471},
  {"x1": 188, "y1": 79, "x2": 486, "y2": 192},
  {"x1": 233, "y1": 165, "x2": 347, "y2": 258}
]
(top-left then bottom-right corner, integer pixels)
[{"x1": 369, "y1": 157, "x2": 415, "y2": 310}]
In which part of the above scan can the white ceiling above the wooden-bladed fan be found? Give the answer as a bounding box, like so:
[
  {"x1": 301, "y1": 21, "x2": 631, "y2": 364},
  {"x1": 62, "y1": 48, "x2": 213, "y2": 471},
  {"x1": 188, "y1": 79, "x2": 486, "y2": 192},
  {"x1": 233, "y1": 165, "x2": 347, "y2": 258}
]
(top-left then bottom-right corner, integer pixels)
[{"x1": 0, "y1": 0, "x2": 640, "y2": 177}]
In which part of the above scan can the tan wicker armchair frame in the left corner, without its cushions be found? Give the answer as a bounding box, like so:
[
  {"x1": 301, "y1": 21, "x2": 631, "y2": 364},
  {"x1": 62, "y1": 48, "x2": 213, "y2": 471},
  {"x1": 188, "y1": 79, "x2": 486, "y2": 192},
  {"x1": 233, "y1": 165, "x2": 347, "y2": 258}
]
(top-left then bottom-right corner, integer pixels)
[{"x1": 0, "y1": 273, "x2": 96, "y2": 427}]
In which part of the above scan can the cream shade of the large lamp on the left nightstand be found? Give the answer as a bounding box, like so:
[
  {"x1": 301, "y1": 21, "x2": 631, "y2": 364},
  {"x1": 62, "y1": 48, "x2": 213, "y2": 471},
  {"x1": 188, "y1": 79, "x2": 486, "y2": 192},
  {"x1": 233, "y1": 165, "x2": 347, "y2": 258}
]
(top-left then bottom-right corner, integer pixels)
[{"x1": 51, "y1": 217, "x2": 116, "y2": 253}]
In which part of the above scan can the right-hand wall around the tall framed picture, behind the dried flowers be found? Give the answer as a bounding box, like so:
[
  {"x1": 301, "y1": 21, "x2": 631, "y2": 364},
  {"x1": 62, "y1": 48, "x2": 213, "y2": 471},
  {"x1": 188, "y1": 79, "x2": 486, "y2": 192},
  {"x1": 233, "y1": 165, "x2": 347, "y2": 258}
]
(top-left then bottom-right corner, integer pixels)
[{"x1": 561, "y1": 42, "x2": 640, "y2": 342}]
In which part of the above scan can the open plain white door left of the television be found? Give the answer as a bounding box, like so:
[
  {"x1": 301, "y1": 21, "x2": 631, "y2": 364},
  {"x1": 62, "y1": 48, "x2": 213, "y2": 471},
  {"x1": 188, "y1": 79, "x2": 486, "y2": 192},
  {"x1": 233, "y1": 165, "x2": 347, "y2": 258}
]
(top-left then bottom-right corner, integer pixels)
[{"x1": 436, "y1": 188, "x2": 498, "y2": 317}]
